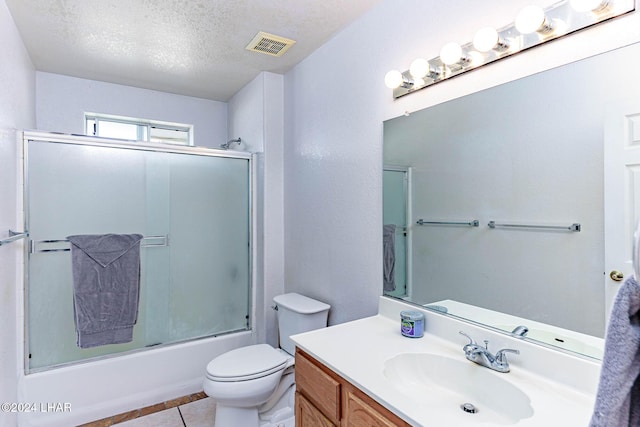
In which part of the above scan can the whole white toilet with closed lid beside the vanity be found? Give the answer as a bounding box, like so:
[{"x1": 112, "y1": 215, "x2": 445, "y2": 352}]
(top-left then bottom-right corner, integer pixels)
[{"x1": 203, "y1": 293, "x2": 330, "y2": 427}]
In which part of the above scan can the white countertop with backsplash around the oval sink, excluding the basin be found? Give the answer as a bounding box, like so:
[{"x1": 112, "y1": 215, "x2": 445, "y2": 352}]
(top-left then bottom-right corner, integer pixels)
[{"x1": 292, "y1": 298, "x2": 599, "y2": 427}]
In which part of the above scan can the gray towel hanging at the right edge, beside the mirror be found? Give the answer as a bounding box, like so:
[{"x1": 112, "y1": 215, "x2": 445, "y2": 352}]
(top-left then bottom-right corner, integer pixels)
[{"x1": 589, "y1": 276, "x2": 640, "y2": 427}]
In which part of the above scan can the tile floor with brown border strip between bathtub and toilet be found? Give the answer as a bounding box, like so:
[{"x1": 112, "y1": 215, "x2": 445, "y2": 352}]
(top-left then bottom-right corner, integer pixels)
[{"x1": 80, "y1": 393, "x2": 216, "y2": 427}]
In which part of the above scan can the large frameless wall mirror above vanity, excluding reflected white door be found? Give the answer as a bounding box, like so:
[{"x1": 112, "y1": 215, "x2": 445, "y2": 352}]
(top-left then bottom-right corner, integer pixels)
[{"x1": 383, "y1": 44, "x2": 640, "y2": 358}]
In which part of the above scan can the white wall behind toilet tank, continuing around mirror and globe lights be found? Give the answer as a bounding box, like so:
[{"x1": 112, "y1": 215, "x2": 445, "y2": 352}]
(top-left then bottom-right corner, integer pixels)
[{"x1": 284, "y1": 0, "x2": 640, "y2": 323}]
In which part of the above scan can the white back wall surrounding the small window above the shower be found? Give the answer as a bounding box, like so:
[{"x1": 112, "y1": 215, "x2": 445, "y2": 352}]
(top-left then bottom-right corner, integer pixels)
[{"x1": 36, "y1": 71, "x2": 227, "y2": 148}]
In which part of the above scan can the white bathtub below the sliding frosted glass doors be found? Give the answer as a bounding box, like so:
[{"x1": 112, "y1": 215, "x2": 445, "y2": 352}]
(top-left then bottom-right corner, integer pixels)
[{"x1": 14, "y1": 331, "x2": 255, "y2": 427}]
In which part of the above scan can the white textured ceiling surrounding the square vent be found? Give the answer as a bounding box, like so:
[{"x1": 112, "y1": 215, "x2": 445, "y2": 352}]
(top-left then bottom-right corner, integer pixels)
[{"x1": 5, "y1": 0, "x2": 380, "y2": 101}]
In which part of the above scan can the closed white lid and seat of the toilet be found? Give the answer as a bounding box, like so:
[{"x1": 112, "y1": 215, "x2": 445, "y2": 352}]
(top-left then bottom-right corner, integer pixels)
[{"x1": 207, "y1": 344, "x2": 287, "y2": 381}]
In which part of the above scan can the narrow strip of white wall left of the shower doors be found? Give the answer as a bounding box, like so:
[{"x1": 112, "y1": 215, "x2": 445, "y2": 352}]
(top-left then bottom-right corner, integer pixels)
[{"x1": 0, "y1": 0, "x2": 35, "y2": 427}]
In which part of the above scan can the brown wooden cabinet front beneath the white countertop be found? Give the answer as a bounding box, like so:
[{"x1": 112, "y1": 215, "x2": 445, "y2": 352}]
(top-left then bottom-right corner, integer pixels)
[{"x1": 296, "y1": 348, "x2": 410, "y2": 427}]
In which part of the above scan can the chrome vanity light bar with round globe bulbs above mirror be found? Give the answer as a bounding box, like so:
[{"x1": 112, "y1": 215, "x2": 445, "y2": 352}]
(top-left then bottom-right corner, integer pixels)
[{"x1": 384, "y1": 0, "x2": 635, "y2": 98}]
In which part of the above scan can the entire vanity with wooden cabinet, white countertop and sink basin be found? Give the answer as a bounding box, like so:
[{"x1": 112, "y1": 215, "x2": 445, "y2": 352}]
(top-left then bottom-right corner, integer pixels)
[{"x1": 292, "y1": 297, "x2": 600, "y2": 427}]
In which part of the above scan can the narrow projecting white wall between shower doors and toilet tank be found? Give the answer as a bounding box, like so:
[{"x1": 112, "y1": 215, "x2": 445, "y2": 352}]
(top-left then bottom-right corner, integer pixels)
[{"x1": 229, "y1": 72, "x2": 284, "y2": 345}]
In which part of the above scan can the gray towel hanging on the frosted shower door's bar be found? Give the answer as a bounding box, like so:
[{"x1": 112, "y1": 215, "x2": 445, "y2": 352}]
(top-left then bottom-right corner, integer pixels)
[{"x1": 67, "y1": 234, "x2": 142, "y2": 348}]
